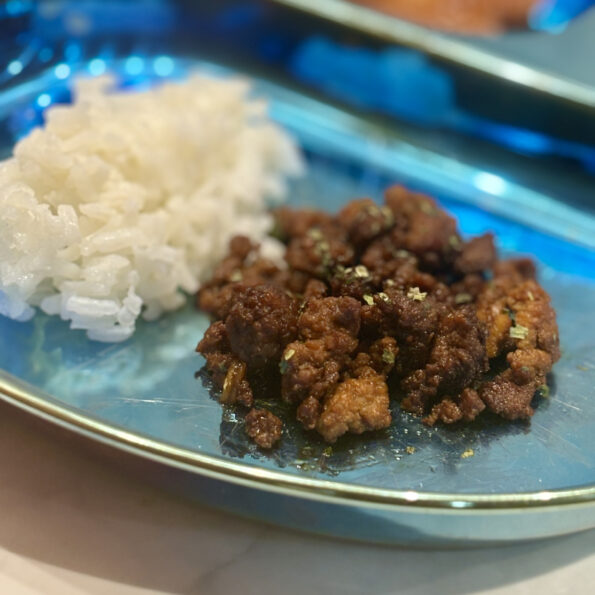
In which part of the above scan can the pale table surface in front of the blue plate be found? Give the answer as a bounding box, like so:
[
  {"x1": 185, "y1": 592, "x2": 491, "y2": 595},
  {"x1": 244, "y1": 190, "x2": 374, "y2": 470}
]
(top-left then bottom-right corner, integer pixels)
[{"x1": 0, "y1": 403, "x2": 595, "y2": 595}]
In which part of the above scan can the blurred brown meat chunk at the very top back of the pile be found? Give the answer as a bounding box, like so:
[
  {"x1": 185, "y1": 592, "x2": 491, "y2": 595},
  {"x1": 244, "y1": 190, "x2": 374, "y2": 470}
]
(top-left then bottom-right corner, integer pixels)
[{"x1": 385, "y1": 186, "x2": 462, "y2": 271}]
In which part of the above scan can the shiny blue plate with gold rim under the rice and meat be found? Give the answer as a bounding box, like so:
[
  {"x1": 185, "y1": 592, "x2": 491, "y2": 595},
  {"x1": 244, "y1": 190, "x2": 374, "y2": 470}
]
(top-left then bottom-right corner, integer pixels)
[{"x1": 0, "y1": 59, "x2": 595, "y2": 544}]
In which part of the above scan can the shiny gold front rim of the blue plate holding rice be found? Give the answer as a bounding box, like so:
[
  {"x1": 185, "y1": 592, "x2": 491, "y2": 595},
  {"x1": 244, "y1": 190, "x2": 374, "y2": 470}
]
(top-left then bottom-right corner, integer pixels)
[{"x1": 0, "y1": 370, "x2": 595, "y2": 513}]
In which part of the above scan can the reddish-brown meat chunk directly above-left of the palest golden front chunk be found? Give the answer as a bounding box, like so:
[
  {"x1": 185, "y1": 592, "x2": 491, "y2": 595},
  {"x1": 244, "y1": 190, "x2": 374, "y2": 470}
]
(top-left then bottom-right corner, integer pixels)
[{"x1": 281, "y1": 297, "x2": 361, "y2": 403}]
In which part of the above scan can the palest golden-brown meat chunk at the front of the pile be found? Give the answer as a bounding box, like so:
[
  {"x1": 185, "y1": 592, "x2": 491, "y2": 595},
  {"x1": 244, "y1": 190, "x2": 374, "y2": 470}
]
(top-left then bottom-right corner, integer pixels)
[{"x1": 316, "y1": 369, "x2": 391, "y2": 443}]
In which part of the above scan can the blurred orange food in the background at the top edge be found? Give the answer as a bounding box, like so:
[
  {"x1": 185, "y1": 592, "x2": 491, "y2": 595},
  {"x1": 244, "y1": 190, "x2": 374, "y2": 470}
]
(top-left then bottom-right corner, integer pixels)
[{"x1": 355, "y1": 0, "x2": 537, "y2": 34}]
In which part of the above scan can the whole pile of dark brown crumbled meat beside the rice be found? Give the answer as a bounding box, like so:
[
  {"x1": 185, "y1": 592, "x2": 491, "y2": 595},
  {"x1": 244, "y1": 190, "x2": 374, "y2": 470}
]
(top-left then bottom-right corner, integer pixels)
[{"x1": 197, "y1": 186, "x2": 560, "y2": 448}]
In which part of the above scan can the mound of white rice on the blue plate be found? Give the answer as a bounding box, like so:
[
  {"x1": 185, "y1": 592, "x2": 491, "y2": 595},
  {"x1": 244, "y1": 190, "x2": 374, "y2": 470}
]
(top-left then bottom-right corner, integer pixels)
[{"x1": 0, "y1": 76, "x2": 300, "y2": 341}]
